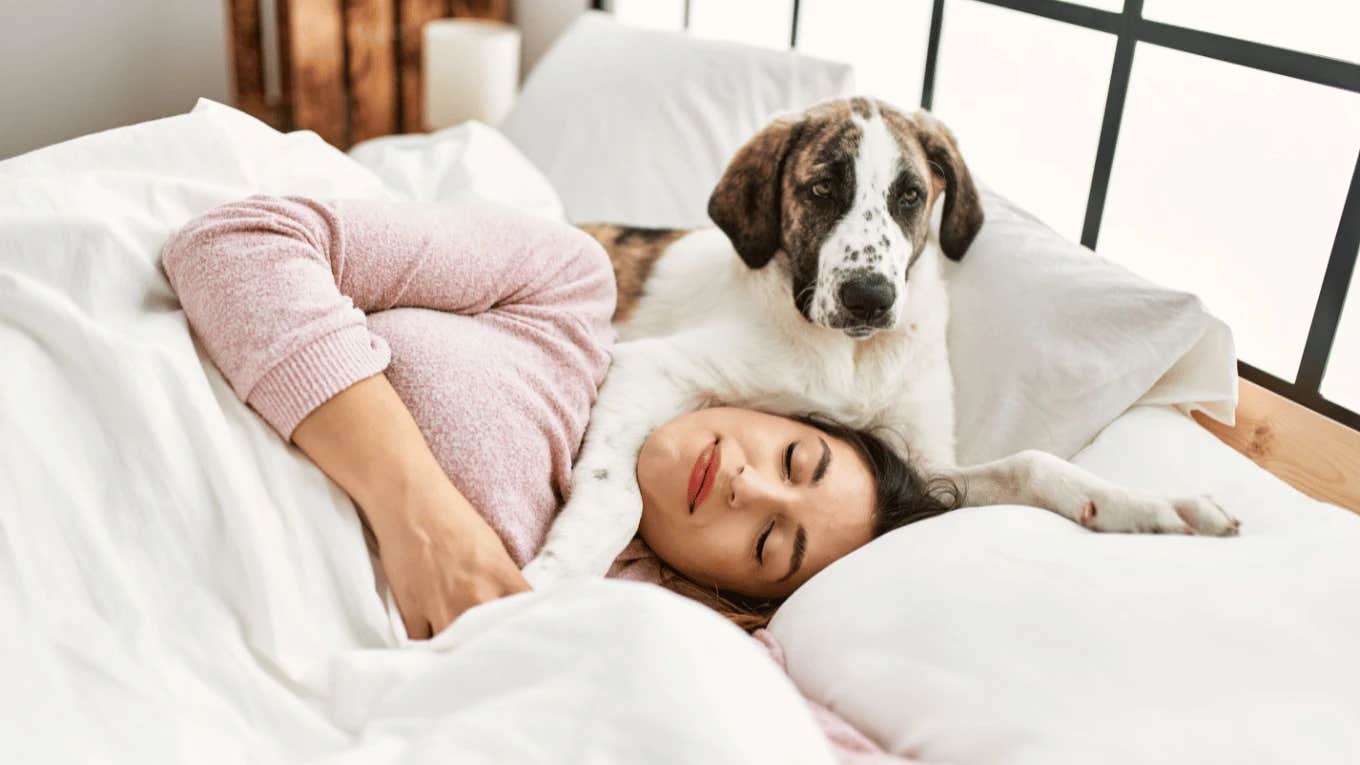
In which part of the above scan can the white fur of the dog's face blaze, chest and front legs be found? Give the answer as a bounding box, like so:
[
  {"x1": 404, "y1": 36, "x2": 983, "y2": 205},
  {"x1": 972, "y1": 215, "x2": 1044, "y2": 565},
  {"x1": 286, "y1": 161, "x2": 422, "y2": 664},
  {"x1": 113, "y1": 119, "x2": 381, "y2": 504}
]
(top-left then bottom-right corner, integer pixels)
[{"x1": 525, "y1": 116, "x2": 1236, "y2": 587}]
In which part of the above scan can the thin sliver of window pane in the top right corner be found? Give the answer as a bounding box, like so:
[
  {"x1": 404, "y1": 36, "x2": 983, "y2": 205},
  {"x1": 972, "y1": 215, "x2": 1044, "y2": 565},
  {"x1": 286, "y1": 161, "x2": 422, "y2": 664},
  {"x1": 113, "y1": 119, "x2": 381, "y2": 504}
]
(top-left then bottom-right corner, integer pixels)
[{"x1": 1142, "y1": 0, "x2": 1360, "y2": 61}]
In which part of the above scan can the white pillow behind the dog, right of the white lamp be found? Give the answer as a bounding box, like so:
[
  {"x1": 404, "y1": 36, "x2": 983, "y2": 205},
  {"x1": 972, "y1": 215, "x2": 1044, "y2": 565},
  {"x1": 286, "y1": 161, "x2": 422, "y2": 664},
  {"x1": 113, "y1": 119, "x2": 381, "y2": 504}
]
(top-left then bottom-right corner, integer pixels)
[{"x1": 500, "y1": 14, "x2": 853, "y2": 227}]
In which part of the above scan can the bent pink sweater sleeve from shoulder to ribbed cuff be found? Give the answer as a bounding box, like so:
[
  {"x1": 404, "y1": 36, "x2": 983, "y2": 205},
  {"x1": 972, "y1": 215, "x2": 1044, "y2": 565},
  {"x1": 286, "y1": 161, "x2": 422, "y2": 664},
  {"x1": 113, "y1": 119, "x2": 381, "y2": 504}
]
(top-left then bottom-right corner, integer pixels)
[{"x1": 162, "y1": 196, "x2": 613, "y2": 438}]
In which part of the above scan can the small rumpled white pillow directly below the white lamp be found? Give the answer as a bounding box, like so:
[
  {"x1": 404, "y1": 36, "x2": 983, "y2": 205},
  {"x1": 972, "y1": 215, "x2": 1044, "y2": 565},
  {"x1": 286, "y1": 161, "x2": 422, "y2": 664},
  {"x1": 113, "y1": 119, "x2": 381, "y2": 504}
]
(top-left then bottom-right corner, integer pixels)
[{"x1": 350, "y1": 121, "x2": 563, "y2": 221}]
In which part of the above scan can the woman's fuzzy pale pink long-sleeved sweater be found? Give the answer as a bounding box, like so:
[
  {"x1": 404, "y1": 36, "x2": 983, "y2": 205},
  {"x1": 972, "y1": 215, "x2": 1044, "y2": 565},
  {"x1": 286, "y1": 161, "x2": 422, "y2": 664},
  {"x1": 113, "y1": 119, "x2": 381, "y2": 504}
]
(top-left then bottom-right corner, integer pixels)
[{"x1": 162, "y1": 196, "x2": 903, "y2": 765}]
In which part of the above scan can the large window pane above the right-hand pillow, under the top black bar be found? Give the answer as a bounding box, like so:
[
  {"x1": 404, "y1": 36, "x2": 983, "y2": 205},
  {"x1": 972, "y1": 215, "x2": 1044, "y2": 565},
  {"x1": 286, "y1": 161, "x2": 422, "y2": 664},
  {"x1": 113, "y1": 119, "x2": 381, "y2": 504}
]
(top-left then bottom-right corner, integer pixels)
[{"x1": 1099, "y1": 45, "x2": 1360, "y2": 380}]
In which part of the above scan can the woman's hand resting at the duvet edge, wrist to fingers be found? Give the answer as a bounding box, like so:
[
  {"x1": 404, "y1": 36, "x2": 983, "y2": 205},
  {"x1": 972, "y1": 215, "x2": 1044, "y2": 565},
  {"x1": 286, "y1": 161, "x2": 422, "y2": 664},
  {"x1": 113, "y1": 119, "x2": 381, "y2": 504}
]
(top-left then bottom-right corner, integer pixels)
[{"x1": 369, "y1": 485, "x2": 529, "y2": 640}]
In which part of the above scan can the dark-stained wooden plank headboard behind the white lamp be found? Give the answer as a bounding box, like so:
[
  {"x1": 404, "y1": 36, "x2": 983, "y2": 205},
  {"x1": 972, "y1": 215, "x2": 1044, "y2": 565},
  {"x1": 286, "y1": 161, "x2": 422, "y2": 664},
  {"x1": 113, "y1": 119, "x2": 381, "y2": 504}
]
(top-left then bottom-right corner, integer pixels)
[{"x1": 227, "y1": 0, "x2": 510, "y2": 148}]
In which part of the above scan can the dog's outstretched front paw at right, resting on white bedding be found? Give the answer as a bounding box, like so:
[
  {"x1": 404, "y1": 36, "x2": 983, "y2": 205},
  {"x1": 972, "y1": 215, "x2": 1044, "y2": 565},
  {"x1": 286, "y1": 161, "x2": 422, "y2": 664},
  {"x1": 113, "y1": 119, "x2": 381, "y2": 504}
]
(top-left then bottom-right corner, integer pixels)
[{"x1": 1077, "y1": 493, "x2": 1242, "y2": 536}]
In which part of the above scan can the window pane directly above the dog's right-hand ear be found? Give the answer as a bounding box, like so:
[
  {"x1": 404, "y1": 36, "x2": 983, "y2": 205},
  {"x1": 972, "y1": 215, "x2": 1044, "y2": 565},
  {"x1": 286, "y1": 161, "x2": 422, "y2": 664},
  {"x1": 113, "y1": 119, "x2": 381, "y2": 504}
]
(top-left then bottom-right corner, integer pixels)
[{"x1": 934, "y1": 0, "x2": 1115, "y2": 241}]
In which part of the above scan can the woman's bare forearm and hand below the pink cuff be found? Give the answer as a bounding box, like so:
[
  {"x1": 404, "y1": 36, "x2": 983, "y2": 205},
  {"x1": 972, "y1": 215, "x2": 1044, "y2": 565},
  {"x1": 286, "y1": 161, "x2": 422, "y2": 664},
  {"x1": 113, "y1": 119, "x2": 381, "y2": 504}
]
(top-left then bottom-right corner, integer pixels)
[{"x1": 292, "y1": 374, "x2": 529, "y2": 640}]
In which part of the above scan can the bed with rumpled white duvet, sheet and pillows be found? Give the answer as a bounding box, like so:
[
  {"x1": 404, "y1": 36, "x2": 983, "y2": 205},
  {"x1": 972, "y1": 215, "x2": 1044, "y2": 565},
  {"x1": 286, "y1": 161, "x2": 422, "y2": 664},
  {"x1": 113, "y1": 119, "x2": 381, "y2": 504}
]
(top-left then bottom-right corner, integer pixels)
[{"x1": 0, "y1": 7, "x2": 1360, "y2": 764}]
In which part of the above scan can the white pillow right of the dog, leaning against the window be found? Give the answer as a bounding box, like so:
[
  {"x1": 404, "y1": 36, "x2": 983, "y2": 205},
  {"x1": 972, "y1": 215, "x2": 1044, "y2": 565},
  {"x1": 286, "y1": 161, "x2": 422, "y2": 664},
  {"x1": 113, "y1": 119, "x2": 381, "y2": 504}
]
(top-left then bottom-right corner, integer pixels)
[{"x1": 945, "y1": 189, "x2": 1238, "y2": 464}]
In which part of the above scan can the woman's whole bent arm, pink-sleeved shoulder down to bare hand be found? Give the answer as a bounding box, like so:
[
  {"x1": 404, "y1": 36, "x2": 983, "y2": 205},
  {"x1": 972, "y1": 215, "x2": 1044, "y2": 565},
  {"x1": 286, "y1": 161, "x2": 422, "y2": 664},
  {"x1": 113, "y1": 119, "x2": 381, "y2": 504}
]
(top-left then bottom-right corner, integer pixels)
[{"x1": 163, "y1": 197, "x2": 613, "y2": 637}]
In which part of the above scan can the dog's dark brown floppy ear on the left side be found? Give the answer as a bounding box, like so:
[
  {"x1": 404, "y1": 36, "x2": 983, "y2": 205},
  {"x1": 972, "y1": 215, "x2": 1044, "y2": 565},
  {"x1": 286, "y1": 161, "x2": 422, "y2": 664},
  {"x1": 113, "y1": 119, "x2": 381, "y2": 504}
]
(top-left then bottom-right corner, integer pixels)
[{"x1": 709, "y1": 117, "x2": 802, "y2": 268}]
